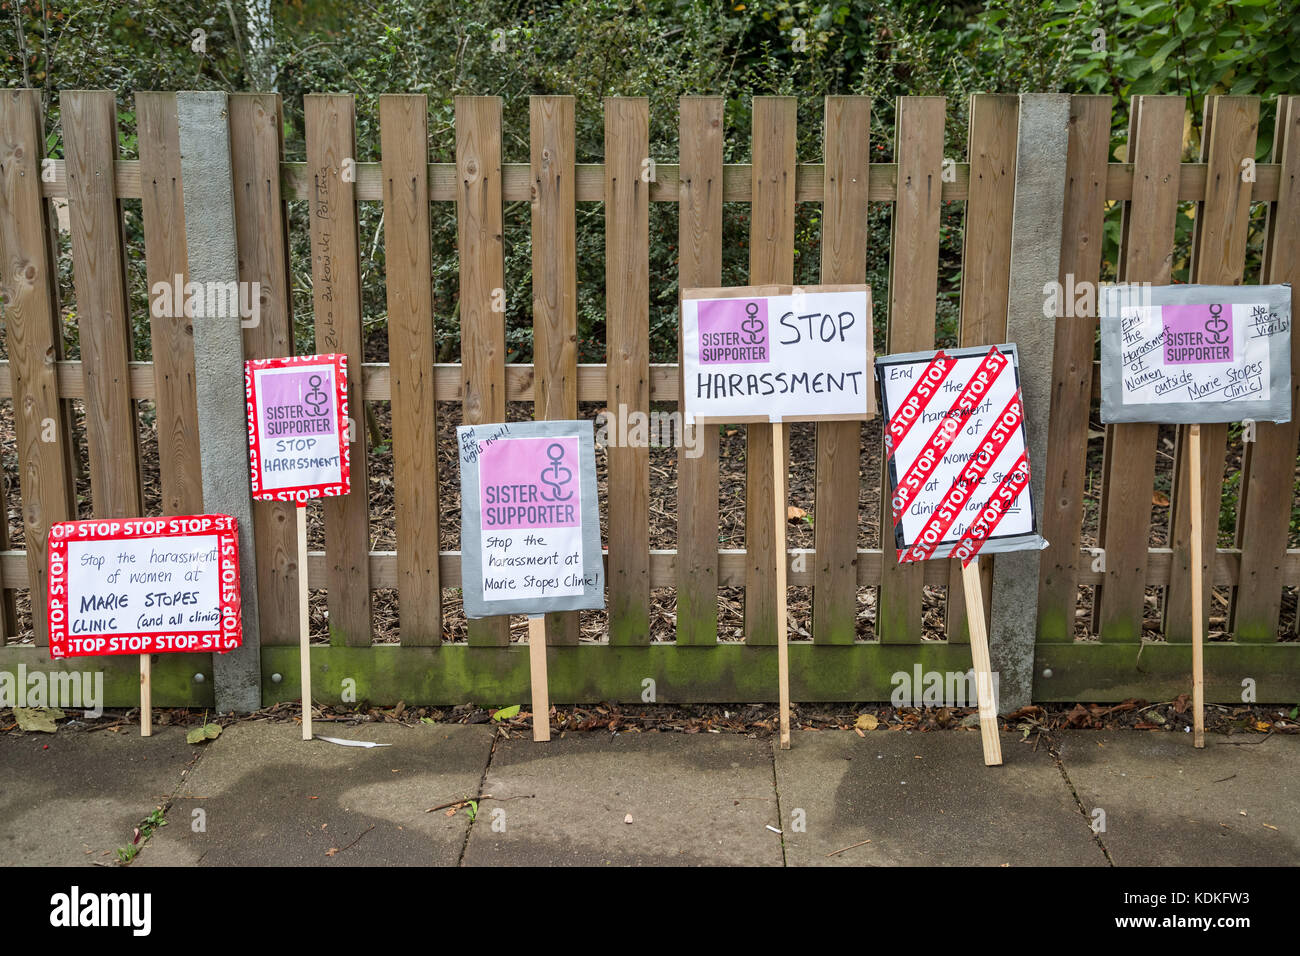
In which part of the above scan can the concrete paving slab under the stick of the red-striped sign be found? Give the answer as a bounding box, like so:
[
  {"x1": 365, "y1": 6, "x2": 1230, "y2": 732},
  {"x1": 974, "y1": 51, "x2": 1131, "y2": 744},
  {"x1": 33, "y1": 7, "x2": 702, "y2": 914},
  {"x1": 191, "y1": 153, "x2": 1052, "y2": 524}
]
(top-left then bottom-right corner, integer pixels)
[{"x1": 776, "y1": 731, "x2": 1106, "y2": 866}]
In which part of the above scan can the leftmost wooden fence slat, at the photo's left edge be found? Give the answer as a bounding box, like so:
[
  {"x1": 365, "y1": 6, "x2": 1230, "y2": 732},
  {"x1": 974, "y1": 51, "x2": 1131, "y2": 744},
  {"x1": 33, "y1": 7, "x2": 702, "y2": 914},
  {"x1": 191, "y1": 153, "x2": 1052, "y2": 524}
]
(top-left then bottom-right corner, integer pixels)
[{"x1": 0, "y1": 90, "x2": 75, "y2": 645}]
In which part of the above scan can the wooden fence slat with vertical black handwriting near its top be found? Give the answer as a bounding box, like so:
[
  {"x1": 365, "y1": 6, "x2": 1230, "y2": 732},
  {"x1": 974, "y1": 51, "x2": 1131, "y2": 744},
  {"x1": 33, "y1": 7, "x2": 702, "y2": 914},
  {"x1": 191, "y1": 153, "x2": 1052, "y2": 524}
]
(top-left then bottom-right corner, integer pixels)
[{"x1": 303, "y1": 95, "x2": 371, "y2": 648}]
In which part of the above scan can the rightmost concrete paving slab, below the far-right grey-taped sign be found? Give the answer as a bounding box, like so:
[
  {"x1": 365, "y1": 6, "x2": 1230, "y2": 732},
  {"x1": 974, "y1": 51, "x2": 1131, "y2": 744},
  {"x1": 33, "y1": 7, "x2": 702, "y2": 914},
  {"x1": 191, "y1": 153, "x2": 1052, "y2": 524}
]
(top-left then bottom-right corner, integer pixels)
[{"x1": 1058, "y1": 731, "x2": 1300, "y2": 866}]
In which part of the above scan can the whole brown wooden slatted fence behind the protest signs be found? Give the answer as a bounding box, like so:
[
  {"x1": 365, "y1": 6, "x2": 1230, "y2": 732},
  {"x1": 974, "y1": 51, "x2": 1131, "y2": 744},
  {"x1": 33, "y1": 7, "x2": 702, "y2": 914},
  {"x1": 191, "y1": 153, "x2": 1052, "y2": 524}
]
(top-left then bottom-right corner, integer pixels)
[{"x1": 0, "y1": 90, "x2": 1300, "y2": 706}]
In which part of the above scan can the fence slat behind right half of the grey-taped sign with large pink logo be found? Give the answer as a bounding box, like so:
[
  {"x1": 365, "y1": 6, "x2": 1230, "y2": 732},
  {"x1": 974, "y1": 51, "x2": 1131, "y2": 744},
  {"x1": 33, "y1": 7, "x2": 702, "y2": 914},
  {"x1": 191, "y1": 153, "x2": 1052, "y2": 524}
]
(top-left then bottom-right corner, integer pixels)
[{"x1": 528, "y1": 96, "x2": 579, "y2": 644}]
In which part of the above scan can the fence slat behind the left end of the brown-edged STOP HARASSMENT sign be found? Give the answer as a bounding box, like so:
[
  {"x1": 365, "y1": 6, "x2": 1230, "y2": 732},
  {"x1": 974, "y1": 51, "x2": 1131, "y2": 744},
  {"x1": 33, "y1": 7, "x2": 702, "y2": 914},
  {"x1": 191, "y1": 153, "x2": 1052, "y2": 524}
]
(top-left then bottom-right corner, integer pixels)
[{"x1": 676, "y1": 96, "x2": 725, "y2": 644}]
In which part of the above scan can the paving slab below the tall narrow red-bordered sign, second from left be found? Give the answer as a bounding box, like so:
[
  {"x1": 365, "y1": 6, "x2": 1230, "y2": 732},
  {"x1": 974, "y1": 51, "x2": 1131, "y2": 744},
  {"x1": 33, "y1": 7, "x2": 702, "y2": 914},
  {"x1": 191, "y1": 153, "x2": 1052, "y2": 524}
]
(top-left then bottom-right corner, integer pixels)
[{"x1": 133, "y1": 723, "x2": 493, "y2": 866}]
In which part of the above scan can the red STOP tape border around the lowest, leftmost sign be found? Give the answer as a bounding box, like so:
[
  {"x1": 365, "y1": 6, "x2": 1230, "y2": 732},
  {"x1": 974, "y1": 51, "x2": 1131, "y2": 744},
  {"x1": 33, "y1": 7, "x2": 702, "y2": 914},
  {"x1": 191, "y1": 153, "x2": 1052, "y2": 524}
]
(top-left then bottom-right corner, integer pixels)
[{"x1": 46, "y1": 515, "x2": 243, "y2": 658}]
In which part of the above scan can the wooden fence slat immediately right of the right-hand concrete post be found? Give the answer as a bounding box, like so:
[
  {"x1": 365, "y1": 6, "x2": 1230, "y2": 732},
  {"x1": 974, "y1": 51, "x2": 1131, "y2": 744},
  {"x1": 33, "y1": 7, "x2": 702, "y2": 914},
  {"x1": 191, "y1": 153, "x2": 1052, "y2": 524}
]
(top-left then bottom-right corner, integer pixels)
[{"x1": 1037, "y1": 96, "x2": 1110, "y2": 641}]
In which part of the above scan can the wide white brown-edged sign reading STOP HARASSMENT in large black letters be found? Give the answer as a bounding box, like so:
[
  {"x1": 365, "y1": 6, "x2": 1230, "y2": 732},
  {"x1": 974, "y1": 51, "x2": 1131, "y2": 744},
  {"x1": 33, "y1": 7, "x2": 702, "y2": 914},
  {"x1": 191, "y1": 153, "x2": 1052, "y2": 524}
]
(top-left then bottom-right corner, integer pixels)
[{"x1": 681, "y1": 285, "x2": 875, "y2": 424}]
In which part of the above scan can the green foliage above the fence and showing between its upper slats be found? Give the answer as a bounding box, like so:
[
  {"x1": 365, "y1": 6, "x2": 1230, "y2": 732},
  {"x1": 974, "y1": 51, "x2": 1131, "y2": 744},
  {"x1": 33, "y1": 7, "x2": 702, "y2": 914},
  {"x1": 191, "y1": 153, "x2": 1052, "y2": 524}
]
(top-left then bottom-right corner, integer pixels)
[{"x1": 0, "y1": 0, "x2": 1300, "y2": 362}]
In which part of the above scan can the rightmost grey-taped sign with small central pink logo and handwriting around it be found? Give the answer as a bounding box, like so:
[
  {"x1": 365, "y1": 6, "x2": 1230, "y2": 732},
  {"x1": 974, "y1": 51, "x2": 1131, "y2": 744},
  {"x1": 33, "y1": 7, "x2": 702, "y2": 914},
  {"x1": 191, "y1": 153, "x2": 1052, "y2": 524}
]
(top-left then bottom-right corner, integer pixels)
[{"x1": 1100, "y1": 285, "x2": 1291, "y2": 424}]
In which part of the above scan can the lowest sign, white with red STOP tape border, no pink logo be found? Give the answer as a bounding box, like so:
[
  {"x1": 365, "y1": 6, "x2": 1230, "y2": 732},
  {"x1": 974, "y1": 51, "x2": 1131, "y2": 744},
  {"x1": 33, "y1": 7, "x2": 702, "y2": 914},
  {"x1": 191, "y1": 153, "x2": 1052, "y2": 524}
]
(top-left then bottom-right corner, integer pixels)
[{"x1": 48, "y1": 515, "x2": 243, "y2": 658}]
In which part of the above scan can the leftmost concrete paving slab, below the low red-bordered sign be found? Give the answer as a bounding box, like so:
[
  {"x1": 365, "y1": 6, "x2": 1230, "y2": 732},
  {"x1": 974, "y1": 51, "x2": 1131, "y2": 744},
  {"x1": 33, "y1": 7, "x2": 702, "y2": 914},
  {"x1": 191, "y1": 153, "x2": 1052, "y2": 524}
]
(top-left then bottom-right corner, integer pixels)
[{"x1": 0, "y1": 727, "x2": 195, "y2": 866}]
